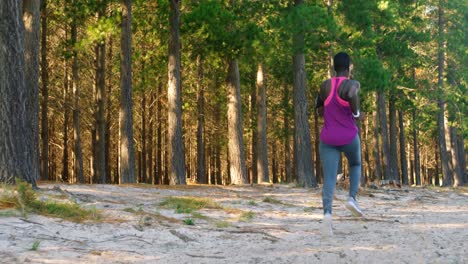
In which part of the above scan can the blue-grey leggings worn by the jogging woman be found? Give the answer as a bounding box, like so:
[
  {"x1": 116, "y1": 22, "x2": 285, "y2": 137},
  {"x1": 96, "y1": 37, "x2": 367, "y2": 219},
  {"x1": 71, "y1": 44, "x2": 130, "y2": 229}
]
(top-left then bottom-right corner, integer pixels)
[{"x1": 319, "y1": 135, "x2": 361, "y2": 214}]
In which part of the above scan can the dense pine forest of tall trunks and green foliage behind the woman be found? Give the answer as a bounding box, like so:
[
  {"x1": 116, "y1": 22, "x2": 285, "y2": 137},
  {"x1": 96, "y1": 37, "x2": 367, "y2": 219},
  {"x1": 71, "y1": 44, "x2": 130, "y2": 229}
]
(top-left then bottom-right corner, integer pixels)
[{"x1": 0, "y1": 0, "x2": 468, "y2": 190}]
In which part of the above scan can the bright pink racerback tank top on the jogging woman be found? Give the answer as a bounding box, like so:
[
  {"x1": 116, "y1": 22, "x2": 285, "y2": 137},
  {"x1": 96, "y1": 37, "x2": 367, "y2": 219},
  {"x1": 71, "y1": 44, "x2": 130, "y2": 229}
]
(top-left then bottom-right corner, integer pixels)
[{"x1": 320, "y1": 77, "x2": 358, "y2": 146}]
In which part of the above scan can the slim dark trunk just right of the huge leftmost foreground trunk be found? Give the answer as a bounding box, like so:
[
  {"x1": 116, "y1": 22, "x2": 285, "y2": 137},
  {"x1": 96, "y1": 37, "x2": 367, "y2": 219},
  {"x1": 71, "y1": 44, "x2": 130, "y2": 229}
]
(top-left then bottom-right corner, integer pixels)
[{"x1": 41, "y1": 0, "x2": 49, "y2": 181}]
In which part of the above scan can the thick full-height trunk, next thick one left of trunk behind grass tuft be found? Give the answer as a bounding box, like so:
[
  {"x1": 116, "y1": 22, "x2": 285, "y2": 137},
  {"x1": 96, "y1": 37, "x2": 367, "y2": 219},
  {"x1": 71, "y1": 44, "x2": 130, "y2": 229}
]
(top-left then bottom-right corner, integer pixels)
[{"x1": 119, "y1": 0, "x2": 136, "y2": 183}]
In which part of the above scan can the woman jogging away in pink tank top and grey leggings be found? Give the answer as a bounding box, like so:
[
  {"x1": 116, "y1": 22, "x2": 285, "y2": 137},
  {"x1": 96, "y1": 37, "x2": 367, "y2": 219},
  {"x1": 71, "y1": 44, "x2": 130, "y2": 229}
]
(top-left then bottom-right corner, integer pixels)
[{"x1": 316, "y1": 52, "x2": 363, "y2": 236}]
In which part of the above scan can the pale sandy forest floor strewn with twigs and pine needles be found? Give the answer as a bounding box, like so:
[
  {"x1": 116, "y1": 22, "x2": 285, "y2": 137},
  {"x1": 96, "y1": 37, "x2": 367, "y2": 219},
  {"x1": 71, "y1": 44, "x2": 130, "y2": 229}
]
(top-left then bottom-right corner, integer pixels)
[{"x1": 0, "y1": 183, "x2": 468, "y2": 264}]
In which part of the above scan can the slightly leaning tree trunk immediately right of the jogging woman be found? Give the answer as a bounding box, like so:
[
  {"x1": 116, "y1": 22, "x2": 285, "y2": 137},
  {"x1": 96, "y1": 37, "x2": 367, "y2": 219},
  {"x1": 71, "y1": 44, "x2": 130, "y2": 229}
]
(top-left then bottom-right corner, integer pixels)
[{"x1": 377, "y1": 91, "x2": 393, "y2": 180}]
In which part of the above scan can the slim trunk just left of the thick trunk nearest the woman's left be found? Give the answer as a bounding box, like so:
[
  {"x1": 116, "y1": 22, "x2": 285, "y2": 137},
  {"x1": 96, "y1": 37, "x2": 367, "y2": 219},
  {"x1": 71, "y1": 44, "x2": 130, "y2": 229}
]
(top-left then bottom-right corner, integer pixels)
[{"x1": 283, "y1": 85, "x2": 293, "y2": 183}]
